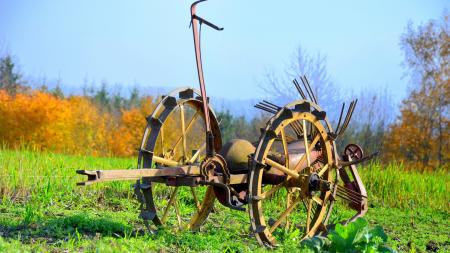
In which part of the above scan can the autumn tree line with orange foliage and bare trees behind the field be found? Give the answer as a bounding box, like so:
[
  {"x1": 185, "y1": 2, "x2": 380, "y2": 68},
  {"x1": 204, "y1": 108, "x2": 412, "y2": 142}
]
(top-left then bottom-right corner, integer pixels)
[{"x1": 0, "y1": 12, "x2": 450, "y2": 170}]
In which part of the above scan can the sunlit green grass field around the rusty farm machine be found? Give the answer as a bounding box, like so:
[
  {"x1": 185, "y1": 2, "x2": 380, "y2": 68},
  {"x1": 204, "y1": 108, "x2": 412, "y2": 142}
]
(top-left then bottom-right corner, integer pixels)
[{"x1": 0, "y1": 150, "x2": 450, "y2": 252}]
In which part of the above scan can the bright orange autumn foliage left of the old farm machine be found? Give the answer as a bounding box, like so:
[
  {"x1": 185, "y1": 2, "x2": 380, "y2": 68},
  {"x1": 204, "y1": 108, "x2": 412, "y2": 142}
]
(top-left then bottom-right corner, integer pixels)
[{"x1": 0, "y1": 90, "x2": 159, "y2": 156}]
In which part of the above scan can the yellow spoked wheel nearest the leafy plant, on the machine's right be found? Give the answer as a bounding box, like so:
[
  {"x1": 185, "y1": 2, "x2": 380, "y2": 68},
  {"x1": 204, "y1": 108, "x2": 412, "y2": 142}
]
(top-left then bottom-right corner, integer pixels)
[{"x1": 249, "y1": 101, "x2": 336, "y2": 247}]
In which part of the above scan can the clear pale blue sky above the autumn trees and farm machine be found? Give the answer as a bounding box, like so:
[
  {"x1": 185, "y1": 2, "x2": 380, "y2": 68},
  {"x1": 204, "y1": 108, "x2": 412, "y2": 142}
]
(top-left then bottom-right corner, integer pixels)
[{"x1": 0, "y1": 0, "x2": 449, "y2": 99}]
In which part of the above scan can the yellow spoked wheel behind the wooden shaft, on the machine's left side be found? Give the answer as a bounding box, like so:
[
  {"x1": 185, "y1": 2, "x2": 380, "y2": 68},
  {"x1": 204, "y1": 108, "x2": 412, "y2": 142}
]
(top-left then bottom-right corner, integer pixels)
[{"x1": 137, "y1": 89, "x2": 222, "y2": 230}]
